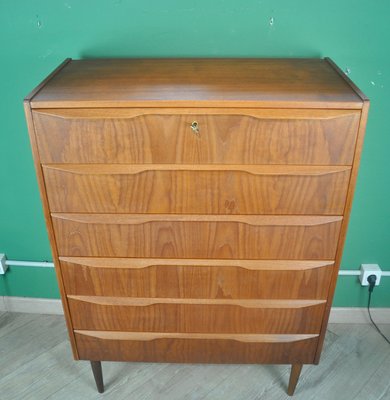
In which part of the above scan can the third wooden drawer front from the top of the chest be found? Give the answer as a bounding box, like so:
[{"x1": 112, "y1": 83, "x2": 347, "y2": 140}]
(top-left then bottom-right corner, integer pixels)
[{"x1": 52, "y1": 214, "x2": 342, "y2": 260}]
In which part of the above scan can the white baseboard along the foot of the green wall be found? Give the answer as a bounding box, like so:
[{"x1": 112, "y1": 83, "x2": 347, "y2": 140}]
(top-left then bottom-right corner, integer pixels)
[{"x1": 0, "y1": 296, "x2": 390, "y2": 324}]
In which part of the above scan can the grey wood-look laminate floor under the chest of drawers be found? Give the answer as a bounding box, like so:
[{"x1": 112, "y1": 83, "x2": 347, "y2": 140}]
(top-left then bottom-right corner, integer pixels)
[{"x1": 0, "y1": 312, "x2": 390, "y2": 400}]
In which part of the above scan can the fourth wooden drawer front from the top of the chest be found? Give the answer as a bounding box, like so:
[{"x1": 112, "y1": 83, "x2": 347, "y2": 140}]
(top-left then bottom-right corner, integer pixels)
[{"x1": 60, "y1": 257, "x2": 334, "y2": 300}]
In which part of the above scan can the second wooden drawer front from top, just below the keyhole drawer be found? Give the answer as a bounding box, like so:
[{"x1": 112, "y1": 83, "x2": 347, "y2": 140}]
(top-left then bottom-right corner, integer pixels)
[{"x1": 43, "y1": 164, "x2": 350, "y2": 215}]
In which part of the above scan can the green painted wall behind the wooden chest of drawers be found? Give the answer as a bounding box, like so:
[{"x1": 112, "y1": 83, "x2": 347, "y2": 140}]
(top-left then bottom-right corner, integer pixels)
[{"x1": 0, "y1": 0, "x2": 390, "y2": 307}]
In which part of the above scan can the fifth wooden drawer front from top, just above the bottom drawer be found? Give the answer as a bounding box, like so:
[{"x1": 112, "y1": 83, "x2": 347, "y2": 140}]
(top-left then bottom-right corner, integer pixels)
[{"x1": 68, "y1": 296, "x2": 326, "y2": 334}]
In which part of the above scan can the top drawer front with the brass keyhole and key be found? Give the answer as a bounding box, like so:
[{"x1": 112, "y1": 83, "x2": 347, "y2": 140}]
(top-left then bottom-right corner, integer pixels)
[{"x1": 33, "y1": 108, "x2": 360, "y2": 165}]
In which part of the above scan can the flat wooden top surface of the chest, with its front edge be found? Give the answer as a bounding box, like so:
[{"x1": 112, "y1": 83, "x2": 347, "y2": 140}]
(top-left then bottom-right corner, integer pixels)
[{"x1": 26, "y1": 59, "x2": 365, "y2": 109}]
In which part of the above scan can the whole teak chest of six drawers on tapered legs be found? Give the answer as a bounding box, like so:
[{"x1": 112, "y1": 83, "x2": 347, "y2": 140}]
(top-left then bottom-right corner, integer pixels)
[{"x1": 25, "y1": 59, "x2": 368, "y2": 394}]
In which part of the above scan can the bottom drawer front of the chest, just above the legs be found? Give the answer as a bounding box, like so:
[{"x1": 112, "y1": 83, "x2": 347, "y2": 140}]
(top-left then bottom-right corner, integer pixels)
[{"x1": 75, "y1": 330, "x2": 318, "y2": 364}]
